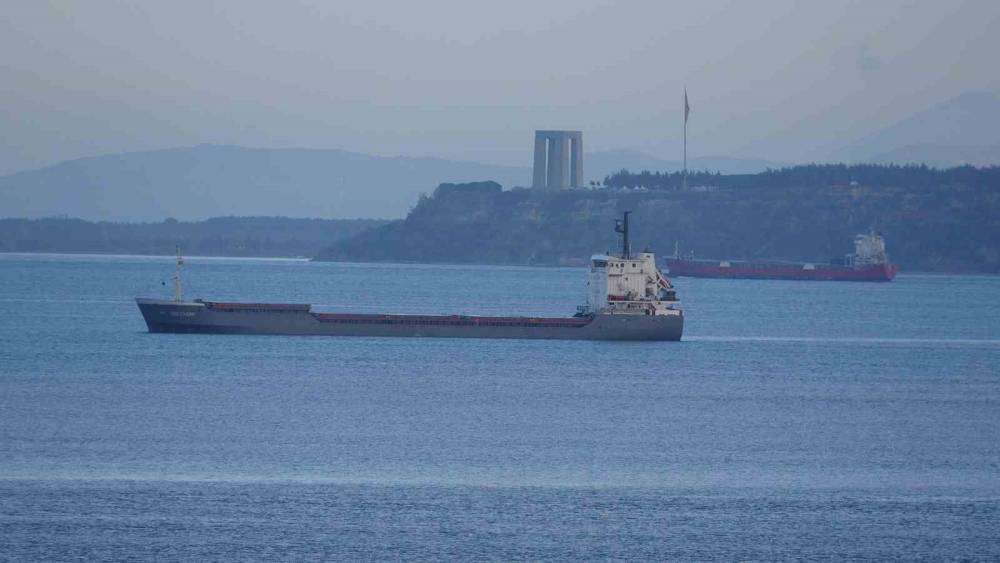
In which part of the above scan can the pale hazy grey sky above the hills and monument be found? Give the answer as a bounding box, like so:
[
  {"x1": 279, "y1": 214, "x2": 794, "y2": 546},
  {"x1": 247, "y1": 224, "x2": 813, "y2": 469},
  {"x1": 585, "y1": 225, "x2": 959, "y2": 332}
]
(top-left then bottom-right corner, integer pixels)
[{"x1": 0, "y1": 0, "x2": 1000, "y2": 173}]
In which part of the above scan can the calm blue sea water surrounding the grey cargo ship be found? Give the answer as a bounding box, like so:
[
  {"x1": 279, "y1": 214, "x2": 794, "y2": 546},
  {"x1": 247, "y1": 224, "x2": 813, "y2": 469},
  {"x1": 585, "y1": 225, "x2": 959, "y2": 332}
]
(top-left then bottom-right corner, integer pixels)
[{"x1": 0, "y1": 255, "x2": 1000, "y2": 560}]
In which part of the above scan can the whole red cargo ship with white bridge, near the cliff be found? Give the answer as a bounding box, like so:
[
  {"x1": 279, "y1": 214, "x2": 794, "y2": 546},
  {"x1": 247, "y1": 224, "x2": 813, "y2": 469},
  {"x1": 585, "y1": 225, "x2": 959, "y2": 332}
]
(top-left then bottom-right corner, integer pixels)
[{"x1": 666, "y1": 232, "x2": 899, "y2": 282}]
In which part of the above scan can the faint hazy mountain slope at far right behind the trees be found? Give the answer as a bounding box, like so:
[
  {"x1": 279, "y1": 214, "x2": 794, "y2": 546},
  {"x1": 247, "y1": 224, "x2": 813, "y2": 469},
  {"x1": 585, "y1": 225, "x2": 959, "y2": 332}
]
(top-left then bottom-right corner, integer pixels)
[{"x1": 835, "y1": 92, "x2": 1000, "y2": 167}]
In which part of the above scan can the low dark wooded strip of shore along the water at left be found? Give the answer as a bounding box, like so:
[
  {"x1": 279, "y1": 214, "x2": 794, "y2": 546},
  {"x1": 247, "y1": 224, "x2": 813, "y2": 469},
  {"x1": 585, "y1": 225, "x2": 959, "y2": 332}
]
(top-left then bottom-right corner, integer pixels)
[{"x1": 0, "y1": 217, "x2": 387, "y2": 257}]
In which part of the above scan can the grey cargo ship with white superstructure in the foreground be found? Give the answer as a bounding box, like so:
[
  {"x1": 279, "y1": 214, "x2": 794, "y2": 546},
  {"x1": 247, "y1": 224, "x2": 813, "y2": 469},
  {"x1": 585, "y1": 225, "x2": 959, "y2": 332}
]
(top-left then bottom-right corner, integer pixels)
[{"x1": 136, "y1": 212, "x2": 684, "y2": 341}]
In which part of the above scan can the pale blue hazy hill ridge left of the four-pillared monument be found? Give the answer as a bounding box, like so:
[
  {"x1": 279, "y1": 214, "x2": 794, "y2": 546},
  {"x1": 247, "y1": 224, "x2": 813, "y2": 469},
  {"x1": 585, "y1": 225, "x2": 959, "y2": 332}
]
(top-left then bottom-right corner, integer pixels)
[{"x1": 0, "y1": 145, "x2": 530, "y2": 221}]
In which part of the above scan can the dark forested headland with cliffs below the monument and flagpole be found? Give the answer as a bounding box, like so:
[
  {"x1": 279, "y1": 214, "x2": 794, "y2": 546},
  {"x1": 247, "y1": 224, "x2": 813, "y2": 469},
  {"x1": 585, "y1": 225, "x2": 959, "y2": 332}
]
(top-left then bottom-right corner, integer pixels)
[{"x1": 319, "y1": 166, "x2": 1000, "y2": 273}]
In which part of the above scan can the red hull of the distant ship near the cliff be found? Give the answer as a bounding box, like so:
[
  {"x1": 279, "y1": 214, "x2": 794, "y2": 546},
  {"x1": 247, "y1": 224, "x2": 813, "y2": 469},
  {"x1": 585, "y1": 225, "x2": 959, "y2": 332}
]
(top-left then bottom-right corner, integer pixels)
[{"x1": 667, "y1": 258, "x2": 899, "y2": 281}]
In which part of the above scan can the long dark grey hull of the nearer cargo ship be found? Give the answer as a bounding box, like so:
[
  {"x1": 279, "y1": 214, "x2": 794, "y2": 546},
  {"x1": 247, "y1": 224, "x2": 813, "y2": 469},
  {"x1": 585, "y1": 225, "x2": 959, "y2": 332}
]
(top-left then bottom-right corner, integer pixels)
[{"x1": 136, "y1": 298, "x2": 684, "y2": 341}]
